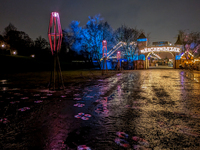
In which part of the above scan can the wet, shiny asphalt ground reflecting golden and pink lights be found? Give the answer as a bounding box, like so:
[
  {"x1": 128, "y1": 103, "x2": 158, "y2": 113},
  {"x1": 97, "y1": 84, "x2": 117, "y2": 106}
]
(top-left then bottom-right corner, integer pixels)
[{"x1": 0, "y1": 69, "x2": 200, "y2": 150}]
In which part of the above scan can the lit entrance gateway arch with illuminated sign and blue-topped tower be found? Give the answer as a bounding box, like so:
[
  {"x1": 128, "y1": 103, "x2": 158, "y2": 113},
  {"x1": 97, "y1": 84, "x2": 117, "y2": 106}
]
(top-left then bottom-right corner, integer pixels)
[{"x1": 134, "y1": 33, "x2": 181, "y2": 69}]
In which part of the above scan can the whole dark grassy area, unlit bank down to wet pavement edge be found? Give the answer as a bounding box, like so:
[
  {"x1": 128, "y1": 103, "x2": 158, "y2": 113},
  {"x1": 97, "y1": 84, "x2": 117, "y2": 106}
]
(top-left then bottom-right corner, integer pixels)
[{"x1": 0, "y1": 55, "x2": 121, "y2": 88}]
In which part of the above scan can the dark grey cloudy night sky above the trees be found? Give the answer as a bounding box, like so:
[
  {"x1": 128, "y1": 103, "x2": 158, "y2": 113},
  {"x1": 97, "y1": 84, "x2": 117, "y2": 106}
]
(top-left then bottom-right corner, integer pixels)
[{"x1": 0, "y1": 0, "x2": 200, "y2": 43}]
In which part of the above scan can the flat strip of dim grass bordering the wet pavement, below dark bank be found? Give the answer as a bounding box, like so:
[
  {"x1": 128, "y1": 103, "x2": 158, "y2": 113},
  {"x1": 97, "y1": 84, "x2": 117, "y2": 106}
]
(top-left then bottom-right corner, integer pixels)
[{"x1": 0, "y1": 70, "x2": 118, "y2": 88}]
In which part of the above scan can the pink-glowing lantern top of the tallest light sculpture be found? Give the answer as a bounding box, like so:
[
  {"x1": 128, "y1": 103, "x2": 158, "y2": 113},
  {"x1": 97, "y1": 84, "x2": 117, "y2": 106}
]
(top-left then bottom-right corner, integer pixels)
[{"x1": 48, "y1": 12, "x2": 63, "y2": 55}]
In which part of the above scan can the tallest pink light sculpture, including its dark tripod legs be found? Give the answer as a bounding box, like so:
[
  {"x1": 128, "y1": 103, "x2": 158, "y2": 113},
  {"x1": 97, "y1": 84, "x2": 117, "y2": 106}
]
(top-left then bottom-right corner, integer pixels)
[{"x1": 48, "y1": 12, "x2": 64, "y2": 90}]
